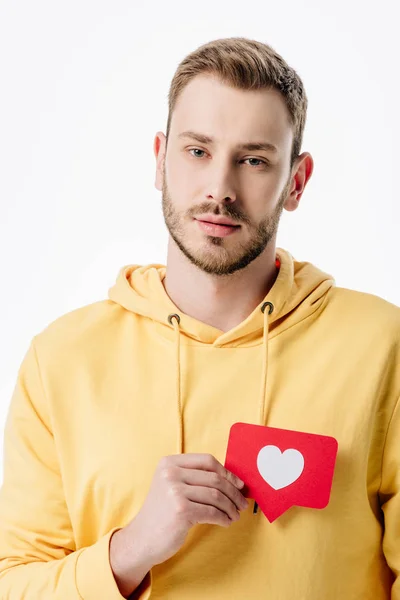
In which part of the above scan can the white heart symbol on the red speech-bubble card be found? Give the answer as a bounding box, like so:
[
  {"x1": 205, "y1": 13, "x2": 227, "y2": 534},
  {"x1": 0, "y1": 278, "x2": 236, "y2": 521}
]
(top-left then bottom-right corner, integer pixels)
[{"x1": 257, "y1": 446, "x2": 304, "y2": 490}]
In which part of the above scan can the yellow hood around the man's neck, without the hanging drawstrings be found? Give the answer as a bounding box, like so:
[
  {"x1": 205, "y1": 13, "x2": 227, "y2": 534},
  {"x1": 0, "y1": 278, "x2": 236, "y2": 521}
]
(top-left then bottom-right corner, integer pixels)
[{"x1": 109, "y1": 248, "x2": 335, "y2": 347}]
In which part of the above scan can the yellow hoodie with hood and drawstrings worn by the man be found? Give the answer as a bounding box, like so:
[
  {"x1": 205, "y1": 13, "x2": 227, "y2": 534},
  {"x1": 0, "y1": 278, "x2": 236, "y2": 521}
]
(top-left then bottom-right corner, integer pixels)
[{"x1": 0, "y1": 248, "x2": 400, "y2": 600}]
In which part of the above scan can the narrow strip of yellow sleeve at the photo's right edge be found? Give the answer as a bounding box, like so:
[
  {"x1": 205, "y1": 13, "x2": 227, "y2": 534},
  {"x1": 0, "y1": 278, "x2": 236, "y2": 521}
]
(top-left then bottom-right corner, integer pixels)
[{"x1": 380, "y1": 398, "x2": 400, "y2": 600}]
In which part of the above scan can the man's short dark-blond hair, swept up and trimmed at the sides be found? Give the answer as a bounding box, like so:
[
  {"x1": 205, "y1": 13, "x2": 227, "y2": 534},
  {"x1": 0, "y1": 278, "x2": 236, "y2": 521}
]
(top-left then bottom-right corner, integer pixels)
[{"x1": 166, "y1": 37, "x2": 307, "y2": 168}]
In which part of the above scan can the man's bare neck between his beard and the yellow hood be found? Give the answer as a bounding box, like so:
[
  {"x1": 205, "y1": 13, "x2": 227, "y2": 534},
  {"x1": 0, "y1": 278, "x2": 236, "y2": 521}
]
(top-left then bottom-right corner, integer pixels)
[{"x1": 163, "y1": 237, "x2": 278, "y2": 332}]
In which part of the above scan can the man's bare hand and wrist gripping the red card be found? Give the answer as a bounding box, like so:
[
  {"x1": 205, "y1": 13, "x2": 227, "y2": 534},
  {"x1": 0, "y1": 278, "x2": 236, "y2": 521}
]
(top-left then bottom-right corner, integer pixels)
[{"x1": 110, "y1": 454, "x2": 248, "y2": 597}]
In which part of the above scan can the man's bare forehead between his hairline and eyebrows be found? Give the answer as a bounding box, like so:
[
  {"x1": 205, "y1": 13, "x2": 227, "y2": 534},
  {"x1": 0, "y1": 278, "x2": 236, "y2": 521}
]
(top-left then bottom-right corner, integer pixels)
[{"x1": 170, "y1": 74, "x2": 292, "y2": 151}]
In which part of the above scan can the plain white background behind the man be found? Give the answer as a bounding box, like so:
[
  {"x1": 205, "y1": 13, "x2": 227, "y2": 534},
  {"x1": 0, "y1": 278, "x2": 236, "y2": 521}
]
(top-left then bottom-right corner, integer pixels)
[{"x1": 0, "y1": 0, "x2": 400, "y2": 475}]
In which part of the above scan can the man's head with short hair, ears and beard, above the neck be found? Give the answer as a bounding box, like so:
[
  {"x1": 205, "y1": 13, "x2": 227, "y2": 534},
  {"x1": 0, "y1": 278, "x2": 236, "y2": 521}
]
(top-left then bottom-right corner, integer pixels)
[{"x1": 154, "y1": 38, "x2": 313, "y2": 275}]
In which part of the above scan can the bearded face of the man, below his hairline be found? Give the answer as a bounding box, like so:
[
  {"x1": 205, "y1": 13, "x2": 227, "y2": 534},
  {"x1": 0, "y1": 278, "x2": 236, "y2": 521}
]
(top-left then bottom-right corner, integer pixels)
[{"x1": 155, "y1": 75, "x2": 304, "y2": 275}]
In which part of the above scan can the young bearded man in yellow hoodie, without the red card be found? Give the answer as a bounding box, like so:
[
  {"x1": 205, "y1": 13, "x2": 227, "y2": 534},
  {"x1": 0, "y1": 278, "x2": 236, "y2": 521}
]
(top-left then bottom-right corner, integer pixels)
[{"x1": 0, "y1": 38, "x2": 400, "y2": 600}]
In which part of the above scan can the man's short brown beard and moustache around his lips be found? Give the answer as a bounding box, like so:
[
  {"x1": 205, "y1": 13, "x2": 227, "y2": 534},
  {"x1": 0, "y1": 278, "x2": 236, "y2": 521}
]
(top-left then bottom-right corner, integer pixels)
[{"x1": 162, "y1": 172, "x2": 291, "y2": 276}]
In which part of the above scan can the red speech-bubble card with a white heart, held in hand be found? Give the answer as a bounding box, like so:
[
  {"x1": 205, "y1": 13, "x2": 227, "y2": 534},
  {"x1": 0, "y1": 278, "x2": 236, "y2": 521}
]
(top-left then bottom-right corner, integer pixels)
[{"x1": 224, "y1": 423, "x2": 338, "y2": 523}]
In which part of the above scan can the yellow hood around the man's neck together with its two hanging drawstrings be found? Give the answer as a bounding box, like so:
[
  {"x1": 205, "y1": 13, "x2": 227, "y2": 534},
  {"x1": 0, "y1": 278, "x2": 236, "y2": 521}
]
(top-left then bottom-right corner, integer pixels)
[{"x1": 109, "y1": 248, "x2": 335, "y2": 454}]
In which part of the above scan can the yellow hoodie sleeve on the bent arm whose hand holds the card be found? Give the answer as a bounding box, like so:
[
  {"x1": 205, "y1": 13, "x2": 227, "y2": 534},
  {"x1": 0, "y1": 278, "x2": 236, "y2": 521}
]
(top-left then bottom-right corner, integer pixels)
[{"x1": 0, "y1": 340, "x2": 151, "y2": 600}]
